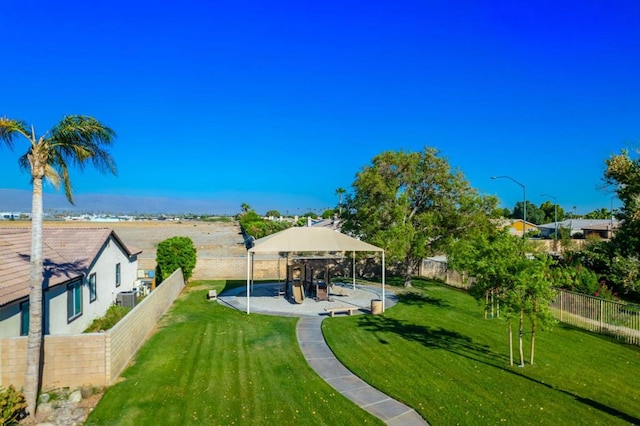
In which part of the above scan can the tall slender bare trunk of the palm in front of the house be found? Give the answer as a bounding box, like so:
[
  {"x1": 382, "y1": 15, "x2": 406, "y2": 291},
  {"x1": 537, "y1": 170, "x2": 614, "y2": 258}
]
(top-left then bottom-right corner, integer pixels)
[{"x1": 24, "y1": 178, "x2": 43, "y2": 417}]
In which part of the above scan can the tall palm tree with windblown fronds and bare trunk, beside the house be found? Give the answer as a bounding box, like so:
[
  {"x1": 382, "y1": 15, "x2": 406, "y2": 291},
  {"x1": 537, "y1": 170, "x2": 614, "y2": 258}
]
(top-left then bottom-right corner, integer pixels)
[{"x1": 0, "y1": 115, "x2": 116, "y2": 416}]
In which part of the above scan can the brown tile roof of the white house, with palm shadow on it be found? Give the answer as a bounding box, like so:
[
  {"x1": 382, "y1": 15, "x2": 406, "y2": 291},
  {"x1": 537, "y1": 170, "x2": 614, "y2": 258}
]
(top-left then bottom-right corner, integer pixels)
[{"x1": 0, "y1": 228, "x2": 140, "y2": 306}]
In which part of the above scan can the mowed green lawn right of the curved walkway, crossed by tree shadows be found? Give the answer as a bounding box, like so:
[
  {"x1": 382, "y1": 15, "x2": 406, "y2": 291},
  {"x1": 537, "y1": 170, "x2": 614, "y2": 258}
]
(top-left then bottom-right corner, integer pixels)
[{"x1": 323, "y1": 280, "x2": 640, "y2": 425}]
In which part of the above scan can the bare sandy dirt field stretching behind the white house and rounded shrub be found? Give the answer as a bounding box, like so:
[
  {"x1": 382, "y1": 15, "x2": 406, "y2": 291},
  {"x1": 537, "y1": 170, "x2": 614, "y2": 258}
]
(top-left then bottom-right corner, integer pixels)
[{"x1": 0, "y1": 221, "x2": 247, "y2": 260}]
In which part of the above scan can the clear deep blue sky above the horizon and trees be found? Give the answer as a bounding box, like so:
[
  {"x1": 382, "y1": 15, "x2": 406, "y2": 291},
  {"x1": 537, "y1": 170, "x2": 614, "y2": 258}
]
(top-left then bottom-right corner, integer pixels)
[{"x1": 0, "y1": 0, "x2": 640, "y2": 213}]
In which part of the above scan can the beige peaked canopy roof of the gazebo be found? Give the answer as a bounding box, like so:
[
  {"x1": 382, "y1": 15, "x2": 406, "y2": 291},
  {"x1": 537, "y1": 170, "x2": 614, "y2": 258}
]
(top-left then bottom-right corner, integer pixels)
[{"x1": 249, "y1": 227, "x2": 384, "y2": 253}]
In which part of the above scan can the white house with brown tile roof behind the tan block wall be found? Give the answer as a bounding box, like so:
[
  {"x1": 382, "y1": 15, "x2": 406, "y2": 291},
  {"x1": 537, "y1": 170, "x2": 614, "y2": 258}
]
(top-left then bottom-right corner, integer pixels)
[{"x1": 0, "y1": 228, "x2": 141, "y2": 338}]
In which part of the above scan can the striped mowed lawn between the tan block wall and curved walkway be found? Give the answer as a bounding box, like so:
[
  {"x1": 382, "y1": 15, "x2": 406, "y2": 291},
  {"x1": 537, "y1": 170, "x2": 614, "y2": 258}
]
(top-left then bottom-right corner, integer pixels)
[{"x1": 86, "y1": 282, "x2": 381, "y2": 425}]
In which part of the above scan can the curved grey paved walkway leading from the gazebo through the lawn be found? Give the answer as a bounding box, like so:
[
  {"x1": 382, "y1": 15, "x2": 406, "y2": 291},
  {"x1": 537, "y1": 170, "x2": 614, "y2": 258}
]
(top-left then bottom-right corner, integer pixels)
[{"x1": 296, "y1": 316, "x2": 427, "y2": 426}]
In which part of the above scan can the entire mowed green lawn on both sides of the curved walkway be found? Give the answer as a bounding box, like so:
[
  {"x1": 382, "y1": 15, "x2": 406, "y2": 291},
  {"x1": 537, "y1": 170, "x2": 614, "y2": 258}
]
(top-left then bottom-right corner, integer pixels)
[{"x1": 87, "y1": 281, "x2": 640, "y2": 425}]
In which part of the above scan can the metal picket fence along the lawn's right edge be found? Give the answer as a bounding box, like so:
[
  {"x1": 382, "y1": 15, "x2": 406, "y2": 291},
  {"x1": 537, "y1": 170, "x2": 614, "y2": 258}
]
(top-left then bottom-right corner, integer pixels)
[{"x1": 551, "y1": 290, "x2": 640, "y2": 346}]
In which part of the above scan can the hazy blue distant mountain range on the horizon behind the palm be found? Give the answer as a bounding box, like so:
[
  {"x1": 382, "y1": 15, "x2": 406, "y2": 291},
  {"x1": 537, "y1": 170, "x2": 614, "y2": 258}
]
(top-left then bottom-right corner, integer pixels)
[{"x1": 0, "y1": 189, "x2": 240, "y2": 215}]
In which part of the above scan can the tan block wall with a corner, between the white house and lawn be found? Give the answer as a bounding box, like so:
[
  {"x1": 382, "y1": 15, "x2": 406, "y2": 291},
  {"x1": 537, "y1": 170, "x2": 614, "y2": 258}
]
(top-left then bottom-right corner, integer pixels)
[{"x1": 0, "y1": 270, "x2": 184, "y2": 389}]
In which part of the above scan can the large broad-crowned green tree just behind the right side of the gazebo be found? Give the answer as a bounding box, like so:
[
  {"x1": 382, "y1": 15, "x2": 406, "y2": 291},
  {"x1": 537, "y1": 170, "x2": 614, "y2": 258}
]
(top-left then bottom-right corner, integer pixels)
[{"x1": 343, "y1": 147, "x2": 497, "y2": 286}]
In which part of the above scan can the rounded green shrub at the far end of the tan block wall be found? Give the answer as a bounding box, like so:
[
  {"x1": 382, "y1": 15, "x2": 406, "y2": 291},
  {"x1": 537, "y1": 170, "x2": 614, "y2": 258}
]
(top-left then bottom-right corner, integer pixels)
[{"x1": 156, "y1": 237, "x2": 198, "y2": 284}]
